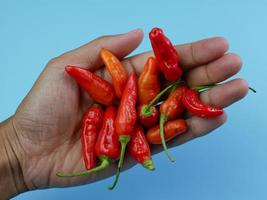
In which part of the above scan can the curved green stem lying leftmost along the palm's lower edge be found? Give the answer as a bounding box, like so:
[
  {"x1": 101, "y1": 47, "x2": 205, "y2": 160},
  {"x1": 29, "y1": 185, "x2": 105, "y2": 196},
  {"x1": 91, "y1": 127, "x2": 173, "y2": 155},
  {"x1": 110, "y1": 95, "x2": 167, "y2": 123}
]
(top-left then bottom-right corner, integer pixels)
[{"x1": 57, "y1": 156, "x2": 110, "y2": 177}]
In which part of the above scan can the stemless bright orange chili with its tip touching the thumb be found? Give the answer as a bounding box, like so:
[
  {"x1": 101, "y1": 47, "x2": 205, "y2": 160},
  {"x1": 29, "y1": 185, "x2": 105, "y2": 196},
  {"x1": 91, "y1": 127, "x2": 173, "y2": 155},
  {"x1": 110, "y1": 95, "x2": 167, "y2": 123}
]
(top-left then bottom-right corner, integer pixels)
[{"x1": 100, "y1": 49, "x2": 128, "y2": 98}]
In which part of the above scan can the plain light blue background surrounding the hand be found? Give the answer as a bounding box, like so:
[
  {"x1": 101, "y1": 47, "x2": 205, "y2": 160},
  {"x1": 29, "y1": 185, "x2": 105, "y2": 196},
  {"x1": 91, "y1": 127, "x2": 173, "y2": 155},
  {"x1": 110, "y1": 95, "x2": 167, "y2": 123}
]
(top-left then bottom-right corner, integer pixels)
[{"x1": 0, "y1": 0, "x2": 267, "y2": 200}]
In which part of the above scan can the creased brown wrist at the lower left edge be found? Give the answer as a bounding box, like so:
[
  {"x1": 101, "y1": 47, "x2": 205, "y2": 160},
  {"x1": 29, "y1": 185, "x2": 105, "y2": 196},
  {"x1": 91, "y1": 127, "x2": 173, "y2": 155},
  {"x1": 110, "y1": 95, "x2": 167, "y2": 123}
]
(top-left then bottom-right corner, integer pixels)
[{"x1": 0, "y1": 118, "x2": 27, "y2": 200}]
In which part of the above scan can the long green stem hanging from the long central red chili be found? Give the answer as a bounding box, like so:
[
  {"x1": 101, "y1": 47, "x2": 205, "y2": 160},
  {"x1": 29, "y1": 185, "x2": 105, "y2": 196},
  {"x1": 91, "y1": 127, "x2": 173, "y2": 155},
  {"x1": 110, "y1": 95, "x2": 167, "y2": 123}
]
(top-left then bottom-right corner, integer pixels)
[{"x1": 108, "y1": 135, "x2": 131, "y2": 190}]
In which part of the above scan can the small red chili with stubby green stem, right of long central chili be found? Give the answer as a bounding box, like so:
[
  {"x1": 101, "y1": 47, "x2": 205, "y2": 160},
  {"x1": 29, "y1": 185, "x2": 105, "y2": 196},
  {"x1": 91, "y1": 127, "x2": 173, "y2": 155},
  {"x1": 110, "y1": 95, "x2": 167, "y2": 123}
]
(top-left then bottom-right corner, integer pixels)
[{"x1": 129, "y1": 124, "x2": 155, "y2": 170}]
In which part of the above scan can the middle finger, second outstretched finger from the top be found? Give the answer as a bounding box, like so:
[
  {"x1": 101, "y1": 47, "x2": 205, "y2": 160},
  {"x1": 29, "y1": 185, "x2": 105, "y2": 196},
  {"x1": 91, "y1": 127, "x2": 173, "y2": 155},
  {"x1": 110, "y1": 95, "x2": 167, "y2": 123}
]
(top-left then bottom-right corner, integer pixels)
[{"x1": 185, "y1": 53, "x2": 242, "y2": 86}]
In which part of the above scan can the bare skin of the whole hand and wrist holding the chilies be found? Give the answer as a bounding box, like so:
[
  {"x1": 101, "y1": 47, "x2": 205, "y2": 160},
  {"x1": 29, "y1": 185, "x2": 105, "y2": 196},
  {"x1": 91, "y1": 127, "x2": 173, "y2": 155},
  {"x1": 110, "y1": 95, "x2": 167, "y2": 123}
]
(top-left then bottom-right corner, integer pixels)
[{"x1": 0, "y1": 30, "x2": 248, "y2": 199}]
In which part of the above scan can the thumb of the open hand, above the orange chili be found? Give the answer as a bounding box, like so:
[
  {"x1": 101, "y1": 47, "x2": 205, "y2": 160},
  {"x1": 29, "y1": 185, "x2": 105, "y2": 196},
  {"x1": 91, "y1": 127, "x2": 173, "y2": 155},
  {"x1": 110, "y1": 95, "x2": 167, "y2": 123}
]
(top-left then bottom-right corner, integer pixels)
[{"x1": 50, "y1": 29, "x2": 143, "y2": 70}]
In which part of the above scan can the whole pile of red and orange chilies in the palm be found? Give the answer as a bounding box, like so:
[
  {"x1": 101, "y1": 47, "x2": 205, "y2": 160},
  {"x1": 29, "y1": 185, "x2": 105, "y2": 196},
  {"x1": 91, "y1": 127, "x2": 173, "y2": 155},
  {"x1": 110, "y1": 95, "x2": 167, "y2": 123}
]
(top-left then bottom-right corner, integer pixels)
[{"x1": 57, "y1": 28, "x2": 226, "y2": 189}]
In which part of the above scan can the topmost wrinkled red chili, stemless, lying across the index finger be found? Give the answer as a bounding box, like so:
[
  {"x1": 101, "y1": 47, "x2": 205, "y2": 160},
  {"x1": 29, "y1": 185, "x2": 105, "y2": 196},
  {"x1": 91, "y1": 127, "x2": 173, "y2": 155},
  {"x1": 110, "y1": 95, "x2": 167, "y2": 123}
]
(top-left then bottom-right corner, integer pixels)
[{"x1": 149, "y1": 28, "x2": 182, "y2": 81}]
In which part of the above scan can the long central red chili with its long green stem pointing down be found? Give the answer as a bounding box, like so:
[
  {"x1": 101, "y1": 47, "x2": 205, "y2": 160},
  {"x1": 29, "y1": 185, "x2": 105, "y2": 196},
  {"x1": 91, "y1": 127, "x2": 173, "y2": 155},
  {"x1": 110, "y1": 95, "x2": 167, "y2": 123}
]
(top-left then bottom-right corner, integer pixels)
[{"x1": 109, "y1": 73, "x2": 137, "y2": 190}]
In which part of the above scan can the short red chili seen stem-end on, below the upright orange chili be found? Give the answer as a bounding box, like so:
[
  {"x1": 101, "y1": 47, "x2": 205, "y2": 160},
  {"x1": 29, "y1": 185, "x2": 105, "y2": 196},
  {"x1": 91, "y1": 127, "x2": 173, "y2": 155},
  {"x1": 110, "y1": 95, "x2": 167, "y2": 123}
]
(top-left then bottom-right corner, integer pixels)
[{"x1": 137, "y1": 105, "x2": 159, "y2": 128}]
